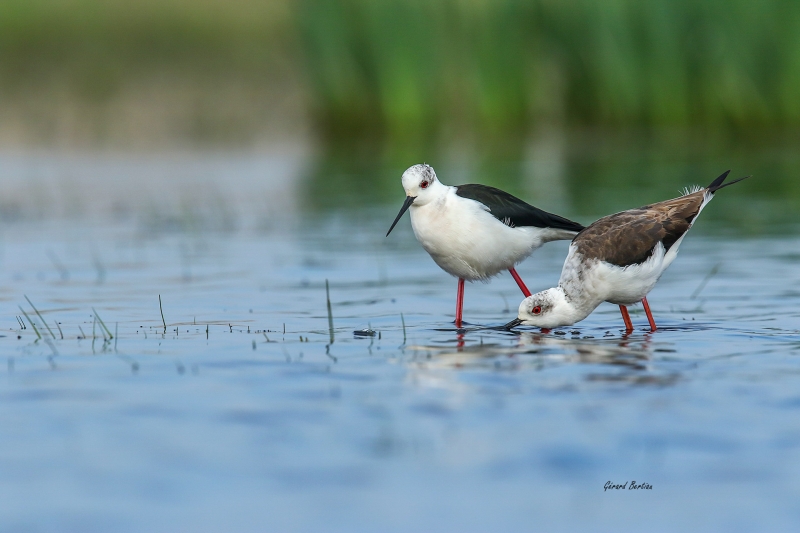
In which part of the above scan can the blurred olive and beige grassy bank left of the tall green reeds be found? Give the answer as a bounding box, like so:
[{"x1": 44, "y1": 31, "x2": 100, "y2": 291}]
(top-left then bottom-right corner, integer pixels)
[{"x1": 0, "y1": 0, "x2": 298, "y2": 143}]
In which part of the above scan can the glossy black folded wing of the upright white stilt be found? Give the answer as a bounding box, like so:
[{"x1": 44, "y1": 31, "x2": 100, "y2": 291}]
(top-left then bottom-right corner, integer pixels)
[{"x1": 456, "y1": 184, "x2": 583, "y2": 231}]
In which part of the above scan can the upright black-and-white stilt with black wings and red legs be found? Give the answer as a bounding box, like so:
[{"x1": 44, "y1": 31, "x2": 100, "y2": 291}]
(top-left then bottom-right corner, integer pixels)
[{"x1": 386, "y1": 164, "x2": 583, "y2": 328}]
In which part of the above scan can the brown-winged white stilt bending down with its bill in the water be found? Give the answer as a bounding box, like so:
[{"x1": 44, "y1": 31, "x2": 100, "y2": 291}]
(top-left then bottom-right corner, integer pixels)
[{"x1": 506, "y1": 170, "x2": 745, "y2": 332}]
